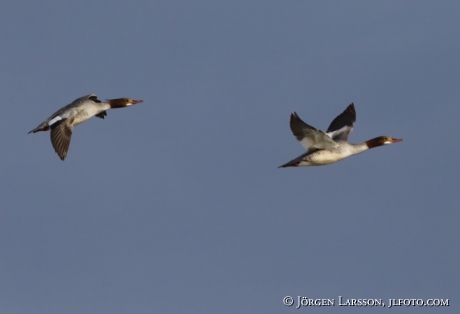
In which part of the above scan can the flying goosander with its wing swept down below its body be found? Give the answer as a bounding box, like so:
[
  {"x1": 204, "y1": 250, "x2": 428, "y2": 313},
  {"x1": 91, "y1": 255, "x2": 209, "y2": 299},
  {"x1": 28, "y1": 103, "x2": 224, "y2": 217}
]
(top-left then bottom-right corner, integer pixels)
[{"x1": 27, "y1": 94, "x2": 143, "y2": 160}]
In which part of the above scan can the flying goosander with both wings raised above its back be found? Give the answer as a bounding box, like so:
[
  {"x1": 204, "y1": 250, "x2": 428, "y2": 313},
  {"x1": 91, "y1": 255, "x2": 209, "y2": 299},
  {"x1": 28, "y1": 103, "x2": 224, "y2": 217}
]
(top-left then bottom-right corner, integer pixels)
[{"x1": 278, "y1": 103, "x2": 403, "y2": 168}]
